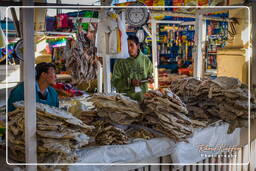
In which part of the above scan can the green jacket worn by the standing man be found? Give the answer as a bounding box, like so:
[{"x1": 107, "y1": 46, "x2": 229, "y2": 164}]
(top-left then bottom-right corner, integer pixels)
[{"x1": 112, "y1": 52, "x2": 153, "y2": 101}]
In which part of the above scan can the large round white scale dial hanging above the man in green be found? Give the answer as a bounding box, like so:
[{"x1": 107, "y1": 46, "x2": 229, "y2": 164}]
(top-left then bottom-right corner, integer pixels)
[{"x1": 126, "y1": 2, "x2": 149, "y2": 27}]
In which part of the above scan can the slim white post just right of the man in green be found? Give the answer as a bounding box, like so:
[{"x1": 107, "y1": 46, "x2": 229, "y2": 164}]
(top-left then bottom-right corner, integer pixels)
[{"x1": 151, "y1": 19, "x2": 158, "y2": 89}]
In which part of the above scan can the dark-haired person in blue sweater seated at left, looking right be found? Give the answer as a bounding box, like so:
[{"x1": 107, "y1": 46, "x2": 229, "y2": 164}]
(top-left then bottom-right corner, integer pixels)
[{"x1": 8, "y1": 62, "x2": 59, "y2": 112}]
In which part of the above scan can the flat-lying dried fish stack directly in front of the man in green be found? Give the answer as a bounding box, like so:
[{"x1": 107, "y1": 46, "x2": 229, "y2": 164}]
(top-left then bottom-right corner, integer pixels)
[{"x1": 88, "y1": 94, "x2": 143, "y2": 125}]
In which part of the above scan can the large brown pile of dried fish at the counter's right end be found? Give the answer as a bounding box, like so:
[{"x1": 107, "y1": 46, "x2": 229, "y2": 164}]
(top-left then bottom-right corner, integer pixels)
[{"x1": 170, "y1": 77, "x2": 256, "y2": 133}]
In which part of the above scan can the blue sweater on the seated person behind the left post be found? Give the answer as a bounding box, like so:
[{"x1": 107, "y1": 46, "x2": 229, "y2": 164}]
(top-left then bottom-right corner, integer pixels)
[{"x1": 8, "y1": 83, "x2": 59, "y2": 112}]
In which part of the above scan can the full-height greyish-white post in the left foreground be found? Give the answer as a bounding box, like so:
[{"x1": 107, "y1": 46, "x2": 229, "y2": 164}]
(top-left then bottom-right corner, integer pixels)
[{"x1": 22, "y1": 0, "x2": 37, "y2": 171}]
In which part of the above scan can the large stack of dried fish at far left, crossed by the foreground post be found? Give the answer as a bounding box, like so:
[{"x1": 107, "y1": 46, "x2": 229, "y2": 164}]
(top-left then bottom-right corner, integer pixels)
[{"x1": 8, "y1": 102, "x2": 94, "y2": 170}]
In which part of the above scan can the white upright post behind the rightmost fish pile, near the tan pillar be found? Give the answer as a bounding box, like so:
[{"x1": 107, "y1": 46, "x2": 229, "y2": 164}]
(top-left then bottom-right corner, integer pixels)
[{"x1": 193, "y1": 13, "x2": 206, "y2": 79}]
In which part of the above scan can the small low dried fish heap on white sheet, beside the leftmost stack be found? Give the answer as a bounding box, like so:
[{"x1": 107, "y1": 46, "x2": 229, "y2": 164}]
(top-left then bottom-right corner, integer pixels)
[{"x1": 94, "y1": 120, "x2": 128, "y2": 145}]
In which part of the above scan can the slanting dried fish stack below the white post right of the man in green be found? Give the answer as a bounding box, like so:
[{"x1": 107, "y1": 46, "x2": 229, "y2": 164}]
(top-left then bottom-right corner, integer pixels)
[{"x1": 143, "y1": 89, "x2": 192, "y2": 141}]
